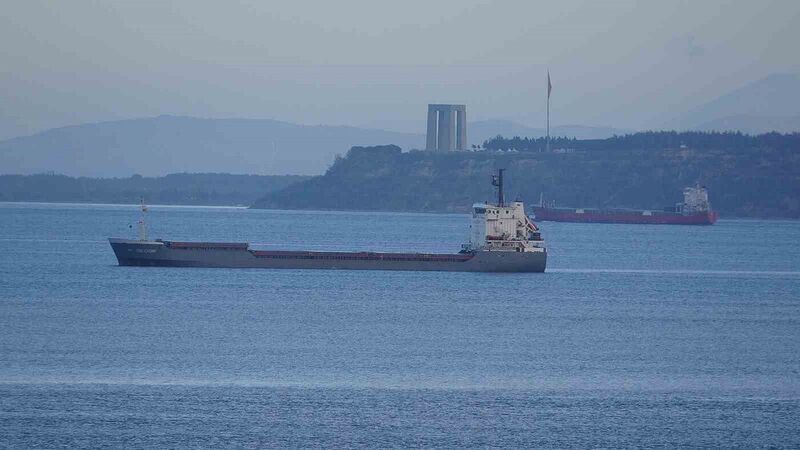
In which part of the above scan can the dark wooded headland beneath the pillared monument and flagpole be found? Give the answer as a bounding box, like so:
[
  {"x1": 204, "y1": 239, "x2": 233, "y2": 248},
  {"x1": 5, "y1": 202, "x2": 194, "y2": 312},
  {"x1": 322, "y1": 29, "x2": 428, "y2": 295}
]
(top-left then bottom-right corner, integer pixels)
[{"x1": 255, "y1": 134, "x2": 800, "y2": 218}]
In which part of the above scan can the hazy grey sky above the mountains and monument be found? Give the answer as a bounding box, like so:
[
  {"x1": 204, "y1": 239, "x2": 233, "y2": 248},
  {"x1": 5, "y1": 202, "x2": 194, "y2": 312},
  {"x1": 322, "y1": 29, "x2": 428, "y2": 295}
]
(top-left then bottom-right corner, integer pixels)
[{"x1": 0, "y1": 0, "x2": 800, "y2": 138}]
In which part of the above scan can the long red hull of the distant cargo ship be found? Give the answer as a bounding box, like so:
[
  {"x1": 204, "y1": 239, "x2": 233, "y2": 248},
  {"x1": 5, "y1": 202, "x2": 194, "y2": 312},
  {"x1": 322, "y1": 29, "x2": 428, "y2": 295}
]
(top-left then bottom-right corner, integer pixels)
[{"x1": 533, "y1": 207, "x2": 718, "y2": 225}]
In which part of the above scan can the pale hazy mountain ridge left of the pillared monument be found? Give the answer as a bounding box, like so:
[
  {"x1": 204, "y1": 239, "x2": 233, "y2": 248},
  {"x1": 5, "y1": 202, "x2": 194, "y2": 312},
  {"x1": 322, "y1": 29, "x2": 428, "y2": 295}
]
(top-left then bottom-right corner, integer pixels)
[{"x1": 0, "y1": 116, "x2": 425, "y2": 177}]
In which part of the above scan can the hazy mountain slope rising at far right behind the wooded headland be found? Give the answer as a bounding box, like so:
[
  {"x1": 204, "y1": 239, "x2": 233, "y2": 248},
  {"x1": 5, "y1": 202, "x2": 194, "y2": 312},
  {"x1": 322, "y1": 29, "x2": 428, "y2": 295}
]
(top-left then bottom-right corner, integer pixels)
[{"x1": 664, "y1": 73, "x2": 800, "y2": 134}]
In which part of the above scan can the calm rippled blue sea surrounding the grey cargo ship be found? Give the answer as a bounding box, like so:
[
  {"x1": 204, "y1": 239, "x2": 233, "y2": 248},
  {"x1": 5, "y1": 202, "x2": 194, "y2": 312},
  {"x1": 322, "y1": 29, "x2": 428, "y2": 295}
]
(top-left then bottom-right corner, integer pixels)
[{"x1": 0, "y1": 204, "x2": 800, "y2": 448}]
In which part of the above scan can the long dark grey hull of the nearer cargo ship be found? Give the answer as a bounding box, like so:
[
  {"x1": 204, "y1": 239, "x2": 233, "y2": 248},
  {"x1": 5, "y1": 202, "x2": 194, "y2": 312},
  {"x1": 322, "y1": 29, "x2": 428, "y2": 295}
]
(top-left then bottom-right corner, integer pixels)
[{"x1": 109, "y1": 238, "x2": 547, "y2": 272}]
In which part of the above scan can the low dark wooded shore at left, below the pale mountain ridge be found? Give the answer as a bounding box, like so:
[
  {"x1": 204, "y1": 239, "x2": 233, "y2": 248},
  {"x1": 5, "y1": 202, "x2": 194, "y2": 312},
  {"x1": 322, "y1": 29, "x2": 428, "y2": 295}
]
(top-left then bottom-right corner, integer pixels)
[{"x1": 0, "y1": 173, "x2": 309, "y2": 206}]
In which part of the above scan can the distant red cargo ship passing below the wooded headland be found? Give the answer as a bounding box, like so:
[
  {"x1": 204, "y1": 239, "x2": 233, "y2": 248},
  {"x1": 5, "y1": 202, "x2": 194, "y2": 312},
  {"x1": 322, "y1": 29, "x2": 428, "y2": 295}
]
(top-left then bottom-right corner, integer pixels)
[{"x1": 532, "y1": 185, "x2": 719, "y2": 225}]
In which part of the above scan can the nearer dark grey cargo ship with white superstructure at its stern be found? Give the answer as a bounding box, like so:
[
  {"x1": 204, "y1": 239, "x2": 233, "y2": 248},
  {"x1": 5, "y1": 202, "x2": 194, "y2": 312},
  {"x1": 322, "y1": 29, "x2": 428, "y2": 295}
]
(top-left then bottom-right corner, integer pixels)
[{"x1": 109, "y1": 170, "x2": 547, "y2": 272}]
